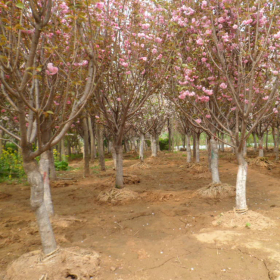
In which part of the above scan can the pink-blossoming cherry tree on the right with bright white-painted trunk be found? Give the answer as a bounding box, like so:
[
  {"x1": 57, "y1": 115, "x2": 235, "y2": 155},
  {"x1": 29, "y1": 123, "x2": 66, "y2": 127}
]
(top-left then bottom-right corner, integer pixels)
[{"x1": 172, "y1": 0, "x2": 280, "y2": 212}]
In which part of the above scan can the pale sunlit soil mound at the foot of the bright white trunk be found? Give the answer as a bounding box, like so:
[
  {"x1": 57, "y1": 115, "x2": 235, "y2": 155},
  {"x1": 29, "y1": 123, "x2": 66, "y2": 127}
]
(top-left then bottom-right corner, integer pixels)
[{"x1": 212, "y1": 210, "x2": 275, "y2": 230}]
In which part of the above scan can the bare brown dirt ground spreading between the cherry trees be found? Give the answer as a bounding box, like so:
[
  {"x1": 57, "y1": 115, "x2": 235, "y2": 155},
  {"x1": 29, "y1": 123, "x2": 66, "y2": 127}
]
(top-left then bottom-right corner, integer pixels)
[{"x1": 0, "y1": 149, "x2": 280, "y2": 280}]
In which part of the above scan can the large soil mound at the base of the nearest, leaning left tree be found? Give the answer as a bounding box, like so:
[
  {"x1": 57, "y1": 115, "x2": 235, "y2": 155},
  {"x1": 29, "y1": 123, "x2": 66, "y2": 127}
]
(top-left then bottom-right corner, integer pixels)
[{"x1": 4, "y1": 247, "x2": 100, "y2": 280}]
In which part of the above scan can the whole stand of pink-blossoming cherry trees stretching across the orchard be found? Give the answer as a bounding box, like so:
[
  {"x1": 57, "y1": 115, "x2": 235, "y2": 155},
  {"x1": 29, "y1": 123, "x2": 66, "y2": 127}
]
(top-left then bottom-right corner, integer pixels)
[{"x1": 0, "y1": 0, "x2": 280, "y2": 254}]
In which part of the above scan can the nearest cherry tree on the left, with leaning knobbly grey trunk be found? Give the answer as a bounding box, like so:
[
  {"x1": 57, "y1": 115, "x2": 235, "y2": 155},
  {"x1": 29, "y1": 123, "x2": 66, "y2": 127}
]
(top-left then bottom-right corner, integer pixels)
[{"x1": 0, "y1": 0, "x2": 102, "y2": 254}]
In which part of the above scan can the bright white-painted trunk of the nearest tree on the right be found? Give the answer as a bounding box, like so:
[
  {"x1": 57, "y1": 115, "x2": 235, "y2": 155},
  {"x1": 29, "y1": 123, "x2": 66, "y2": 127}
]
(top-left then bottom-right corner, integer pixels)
[{"x1": 236, "y1": 151, "x2": 248, "y2": 212}]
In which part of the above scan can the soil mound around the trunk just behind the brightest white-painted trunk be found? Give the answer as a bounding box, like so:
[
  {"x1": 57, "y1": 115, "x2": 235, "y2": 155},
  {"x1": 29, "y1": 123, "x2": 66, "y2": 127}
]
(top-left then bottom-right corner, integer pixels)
[{"x1": 196, "y1": 183, "x2": 236, "y2": 198}]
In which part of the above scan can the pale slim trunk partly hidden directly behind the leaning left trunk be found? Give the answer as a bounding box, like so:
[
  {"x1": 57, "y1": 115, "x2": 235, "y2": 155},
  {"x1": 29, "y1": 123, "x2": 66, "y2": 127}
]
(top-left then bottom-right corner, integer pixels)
[{"x1": 39, "y1": 151, "x2": 54, "y2": 216}]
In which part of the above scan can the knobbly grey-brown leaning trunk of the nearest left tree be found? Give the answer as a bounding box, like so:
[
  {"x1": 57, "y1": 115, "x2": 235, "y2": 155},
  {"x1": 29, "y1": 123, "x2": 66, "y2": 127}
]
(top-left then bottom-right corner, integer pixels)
[{"x1": 23, "y1": 160, "x2": 57, "y2": 254}]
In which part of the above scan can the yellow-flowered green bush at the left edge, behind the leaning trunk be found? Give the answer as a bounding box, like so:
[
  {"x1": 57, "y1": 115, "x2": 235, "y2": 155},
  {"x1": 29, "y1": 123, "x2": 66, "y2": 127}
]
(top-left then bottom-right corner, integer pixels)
[{"x1": 0, "y1": 148, "x2": 25, "y2": 179}]
